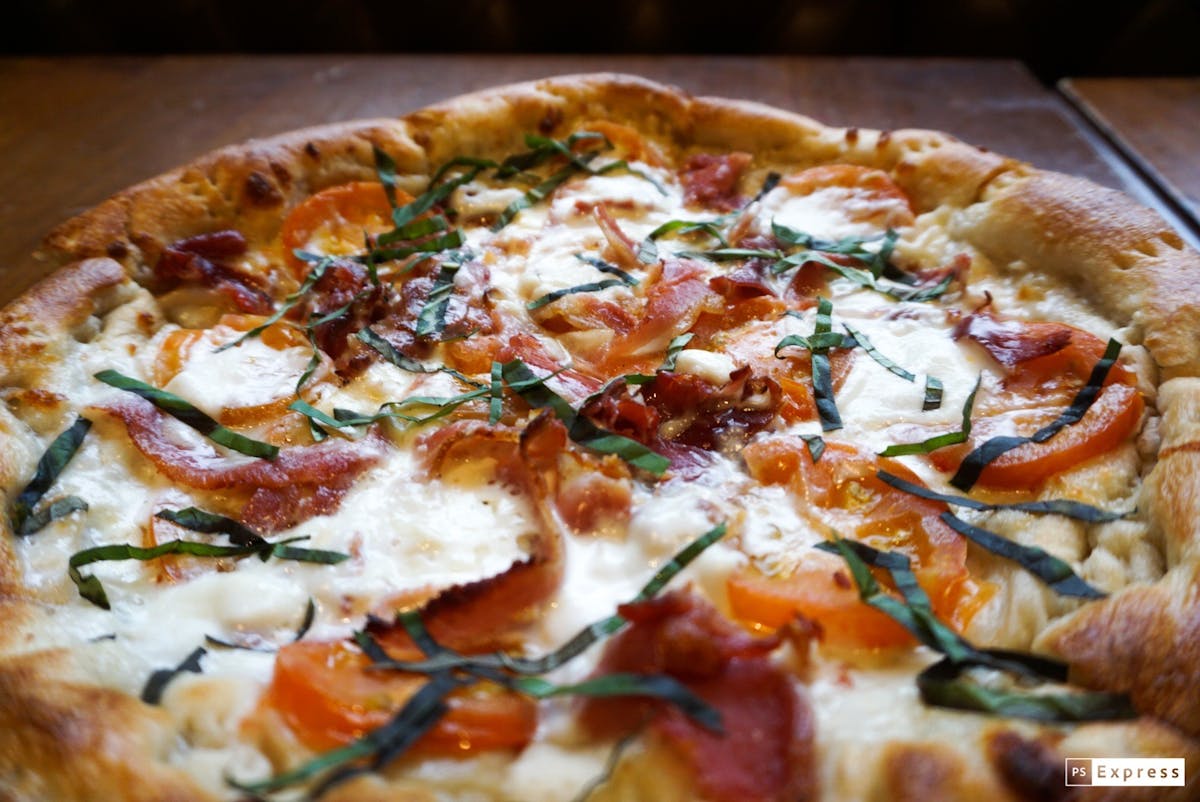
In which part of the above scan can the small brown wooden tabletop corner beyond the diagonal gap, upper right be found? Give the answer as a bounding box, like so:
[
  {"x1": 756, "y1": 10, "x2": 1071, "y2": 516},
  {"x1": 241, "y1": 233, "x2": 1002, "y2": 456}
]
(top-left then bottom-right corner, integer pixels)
[{"x1": 1060, "y1": 78, "x2": 1200, "y2": 226}]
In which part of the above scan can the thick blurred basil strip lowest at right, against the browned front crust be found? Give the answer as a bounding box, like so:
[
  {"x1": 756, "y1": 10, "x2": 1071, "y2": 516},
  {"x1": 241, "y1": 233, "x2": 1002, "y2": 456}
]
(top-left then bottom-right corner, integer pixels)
[{"x1": 917, "y1": 659, "x2": 1138, "y2": 722}]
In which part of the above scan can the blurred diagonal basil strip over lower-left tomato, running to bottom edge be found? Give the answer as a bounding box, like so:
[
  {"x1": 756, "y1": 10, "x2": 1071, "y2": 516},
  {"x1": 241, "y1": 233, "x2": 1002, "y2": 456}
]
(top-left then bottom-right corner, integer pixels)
[{"x1": 226, "y1": 675, "x2": 461, "y2": 800}]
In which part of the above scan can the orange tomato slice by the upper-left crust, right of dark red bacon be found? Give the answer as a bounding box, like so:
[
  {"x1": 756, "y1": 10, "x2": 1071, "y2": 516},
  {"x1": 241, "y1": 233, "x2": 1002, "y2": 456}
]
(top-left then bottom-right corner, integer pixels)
[{"x1": 280, "y1": 181, "x2": 413, "y2": 276}]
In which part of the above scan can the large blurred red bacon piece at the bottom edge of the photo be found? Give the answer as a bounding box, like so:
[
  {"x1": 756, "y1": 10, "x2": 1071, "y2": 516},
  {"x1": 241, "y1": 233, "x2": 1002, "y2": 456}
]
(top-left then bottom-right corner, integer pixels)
[{"x1": 582, "y1": 592, "x2": 816, "y2": 802}]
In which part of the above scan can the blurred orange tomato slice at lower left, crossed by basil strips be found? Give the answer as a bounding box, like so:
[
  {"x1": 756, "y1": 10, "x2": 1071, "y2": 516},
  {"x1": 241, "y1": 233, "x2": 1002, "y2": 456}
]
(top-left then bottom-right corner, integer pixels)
[{"x1": 265, "y1": 641, "x2": 538, "y2": 755}]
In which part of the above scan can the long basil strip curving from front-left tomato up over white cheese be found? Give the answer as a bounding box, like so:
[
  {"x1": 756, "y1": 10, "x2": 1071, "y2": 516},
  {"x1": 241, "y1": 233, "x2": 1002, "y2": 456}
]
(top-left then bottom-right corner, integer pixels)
[{"x1": 355, "y1": 523, "x2": 726, "y2": 676}]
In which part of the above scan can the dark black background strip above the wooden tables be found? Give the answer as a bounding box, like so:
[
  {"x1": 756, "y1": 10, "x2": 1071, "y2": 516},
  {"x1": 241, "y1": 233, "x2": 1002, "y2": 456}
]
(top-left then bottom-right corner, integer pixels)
[{"x1": 7, "y1": 0, "x2": 1200, "y2": 82}]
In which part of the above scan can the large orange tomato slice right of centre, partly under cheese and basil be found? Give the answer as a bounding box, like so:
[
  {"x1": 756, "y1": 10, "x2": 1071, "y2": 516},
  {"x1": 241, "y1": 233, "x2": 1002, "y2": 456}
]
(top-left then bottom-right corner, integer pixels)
[{"x1": 727, "y1": 438, "x2": 979, "y2": 648}]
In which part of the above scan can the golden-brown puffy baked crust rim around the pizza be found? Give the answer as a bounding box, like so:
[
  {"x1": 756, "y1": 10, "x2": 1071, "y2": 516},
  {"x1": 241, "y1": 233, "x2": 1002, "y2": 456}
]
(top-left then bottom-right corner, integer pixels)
[{"x1": 0, "y1": 74, "x2": 1200, "y2": 802}]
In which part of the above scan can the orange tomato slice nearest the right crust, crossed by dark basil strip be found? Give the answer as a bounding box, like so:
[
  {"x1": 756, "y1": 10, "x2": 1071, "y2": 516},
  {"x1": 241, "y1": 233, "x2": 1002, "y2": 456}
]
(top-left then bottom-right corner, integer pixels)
[{"x1": 929, "y1": 321, "x2": 1145, "y2": 490}]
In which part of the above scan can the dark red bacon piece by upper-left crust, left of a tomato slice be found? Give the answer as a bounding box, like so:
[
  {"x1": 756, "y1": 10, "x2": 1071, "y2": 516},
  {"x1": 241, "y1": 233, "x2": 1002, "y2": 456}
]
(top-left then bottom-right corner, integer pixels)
[{"x1": 154, "y1": 229, "x2": 271, "y2": 315}]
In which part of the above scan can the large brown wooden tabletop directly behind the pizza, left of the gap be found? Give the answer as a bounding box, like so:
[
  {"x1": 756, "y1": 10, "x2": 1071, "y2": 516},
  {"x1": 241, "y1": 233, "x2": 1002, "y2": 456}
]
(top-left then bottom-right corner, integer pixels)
[{"x1": 0, "y1": 55, "x2": 1195, "y2": 303}]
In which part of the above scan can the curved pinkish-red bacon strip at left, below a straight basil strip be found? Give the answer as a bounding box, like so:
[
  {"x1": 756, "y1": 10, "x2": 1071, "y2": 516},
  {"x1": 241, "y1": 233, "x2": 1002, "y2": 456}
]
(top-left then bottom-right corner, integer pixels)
[{"x1": 100, "y1": 395, "x2": 383, "y2": 490}]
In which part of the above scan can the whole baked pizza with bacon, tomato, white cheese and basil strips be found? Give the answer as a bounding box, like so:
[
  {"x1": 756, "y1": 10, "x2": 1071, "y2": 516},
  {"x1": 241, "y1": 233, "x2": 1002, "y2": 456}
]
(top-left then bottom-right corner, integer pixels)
[{"x1": 0, "y1": 74, "x2": 1200, "y2": 802}]
